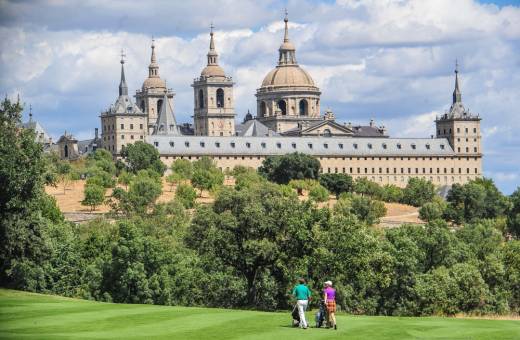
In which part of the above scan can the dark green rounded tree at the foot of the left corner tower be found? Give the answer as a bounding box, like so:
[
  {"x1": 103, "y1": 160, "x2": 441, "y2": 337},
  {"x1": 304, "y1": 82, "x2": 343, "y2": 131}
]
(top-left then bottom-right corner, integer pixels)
[{"x1": 121, "y1": 141, "x2": 166, "y2": 176}]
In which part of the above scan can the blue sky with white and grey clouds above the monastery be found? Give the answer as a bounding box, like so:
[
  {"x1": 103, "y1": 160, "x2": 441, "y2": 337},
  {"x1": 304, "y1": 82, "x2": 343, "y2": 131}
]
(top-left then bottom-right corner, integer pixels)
[{"x1": 0, "y1": 0, "x2": 520, "y2": 193}]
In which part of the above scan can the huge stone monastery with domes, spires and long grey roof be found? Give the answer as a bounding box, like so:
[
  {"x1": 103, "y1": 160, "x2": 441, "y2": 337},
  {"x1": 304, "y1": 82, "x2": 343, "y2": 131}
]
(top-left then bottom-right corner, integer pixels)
[{"x1": 101, "y1": 16, "x2": 482, "y2": 186}]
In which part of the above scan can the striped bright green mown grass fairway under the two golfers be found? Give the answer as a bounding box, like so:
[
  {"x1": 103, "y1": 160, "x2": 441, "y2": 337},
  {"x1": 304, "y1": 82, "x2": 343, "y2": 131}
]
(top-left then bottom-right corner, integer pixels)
[{"x1": 0, "y1": 289, "x2": 520, "y2": 340}]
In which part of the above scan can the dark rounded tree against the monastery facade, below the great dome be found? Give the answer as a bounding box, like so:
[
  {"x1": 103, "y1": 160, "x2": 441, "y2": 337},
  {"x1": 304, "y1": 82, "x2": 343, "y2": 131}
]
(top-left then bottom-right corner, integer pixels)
[{"x1": 258, "y1": 152, "x2": 321, "y2": 184}]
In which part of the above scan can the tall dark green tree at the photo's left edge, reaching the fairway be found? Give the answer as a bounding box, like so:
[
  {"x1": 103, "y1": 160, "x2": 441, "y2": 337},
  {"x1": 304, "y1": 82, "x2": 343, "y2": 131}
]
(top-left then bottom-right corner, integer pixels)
[{"x1": 0, "y1": 98, "x2": 53, "y2": 290}]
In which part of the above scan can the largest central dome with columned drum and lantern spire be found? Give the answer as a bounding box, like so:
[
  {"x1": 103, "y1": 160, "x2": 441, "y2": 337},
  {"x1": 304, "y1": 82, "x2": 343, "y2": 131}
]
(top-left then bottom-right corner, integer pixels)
[{"x1": 256, "y1": 12, "x2": 321, "y2": 132}]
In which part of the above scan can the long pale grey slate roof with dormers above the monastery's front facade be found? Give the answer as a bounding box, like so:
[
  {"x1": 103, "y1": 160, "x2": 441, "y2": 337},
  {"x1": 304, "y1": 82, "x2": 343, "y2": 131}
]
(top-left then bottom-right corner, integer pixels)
[{"x1": 146, "y1": 135, "x2": 455, "y2": 157}]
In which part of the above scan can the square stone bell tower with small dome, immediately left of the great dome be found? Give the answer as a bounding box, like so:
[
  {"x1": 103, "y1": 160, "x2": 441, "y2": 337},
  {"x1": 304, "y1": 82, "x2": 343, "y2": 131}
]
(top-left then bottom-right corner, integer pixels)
[{"x1": 192, "y1": 25, "x2": 235, "y2": 136}]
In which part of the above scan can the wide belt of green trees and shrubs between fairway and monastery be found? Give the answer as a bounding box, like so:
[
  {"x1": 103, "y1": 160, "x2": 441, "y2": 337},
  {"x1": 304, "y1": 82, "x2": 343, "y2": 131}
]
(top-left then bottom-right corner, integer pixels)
[{"x1": 0, "y1": 100, "x2": 520, "y2": 315}]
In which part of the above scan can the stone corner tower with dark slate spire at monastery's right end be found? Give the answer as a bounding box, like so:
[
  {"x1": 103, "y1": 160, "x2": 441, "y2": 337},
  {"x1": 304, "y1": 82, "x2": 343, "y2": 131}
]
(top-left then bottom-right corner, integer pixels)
[{"x1": 435, "y1": 63, "x2": 482, "y2": 158}]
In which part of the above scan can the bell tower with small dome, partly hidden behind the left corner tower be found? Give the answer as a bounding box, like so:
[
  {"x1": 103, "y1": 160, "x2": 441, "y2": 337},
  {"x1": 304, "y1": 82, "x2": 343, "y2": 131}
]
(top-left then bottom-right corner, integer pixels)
[{"x1": 135, "y1": 39, "x2": 175, "y2": 134}]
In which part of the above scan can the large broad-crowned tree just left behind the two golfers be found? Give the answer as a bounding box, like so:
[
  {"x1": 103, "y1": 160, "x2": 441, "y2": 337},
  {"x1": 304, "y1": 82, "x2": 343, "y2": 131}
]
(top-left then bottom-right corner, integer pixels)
[{"x1": 187, "y1": 184, "x2": 319, "y2": 309}]
